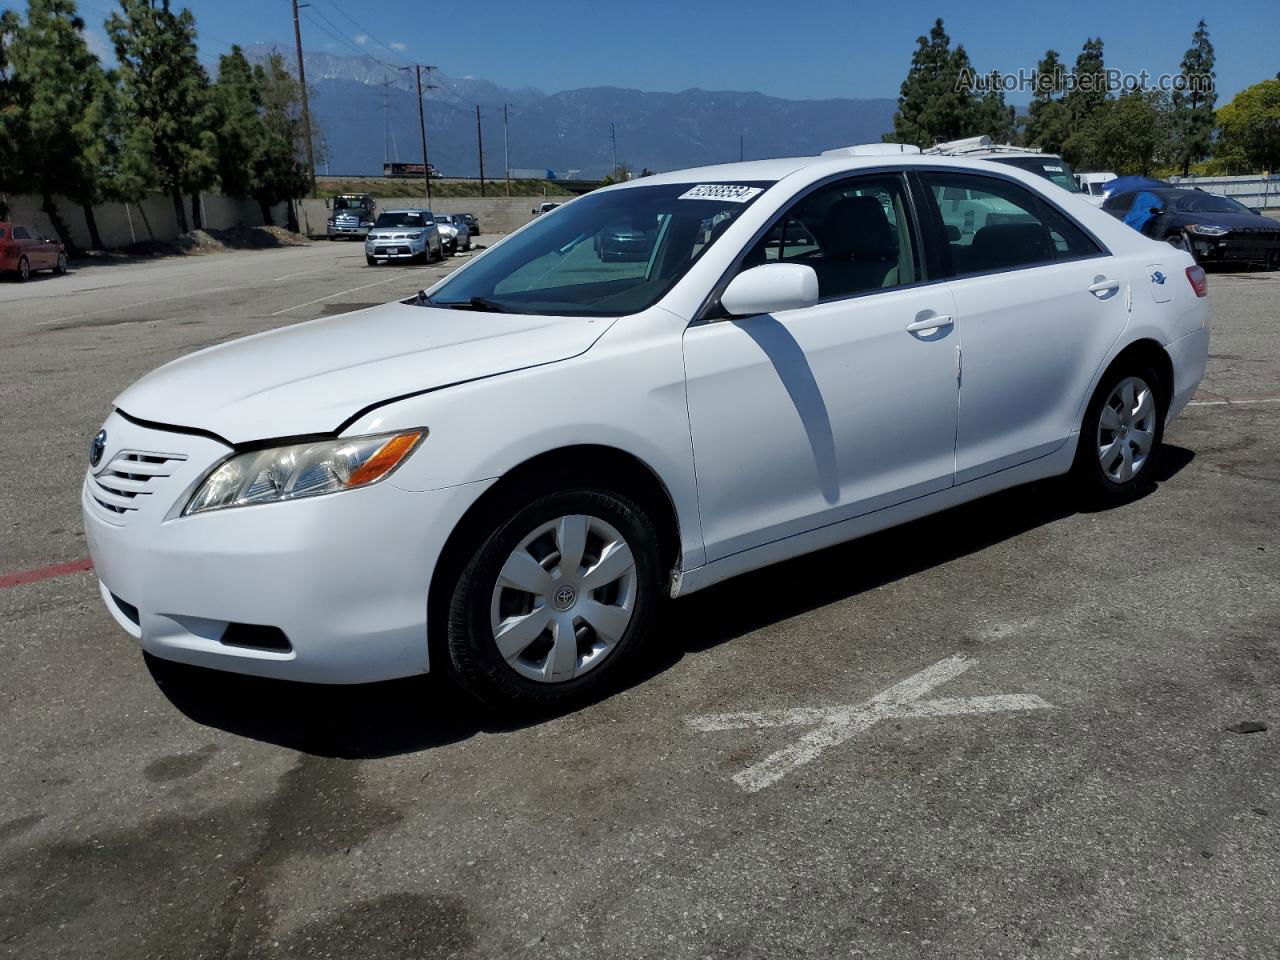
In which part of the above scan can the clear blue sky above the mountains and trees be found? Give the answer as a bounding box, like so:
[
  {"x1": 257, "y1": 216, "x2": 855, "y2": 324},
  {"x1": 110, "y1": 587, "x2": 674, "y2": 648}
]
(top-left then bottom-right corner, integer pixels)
[{"x1": 12, "y1": 0, "x2": 1280, "y2": 104}]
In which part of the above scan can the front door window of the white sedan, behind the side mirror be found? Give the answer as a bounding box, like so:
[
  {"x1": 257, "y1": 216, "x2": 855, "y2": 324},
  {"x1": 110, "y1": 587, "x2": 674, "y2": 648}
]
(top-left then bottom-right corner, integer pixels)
[{"x1": 741, "y1": 174, "x2": 923, "y2": 300}]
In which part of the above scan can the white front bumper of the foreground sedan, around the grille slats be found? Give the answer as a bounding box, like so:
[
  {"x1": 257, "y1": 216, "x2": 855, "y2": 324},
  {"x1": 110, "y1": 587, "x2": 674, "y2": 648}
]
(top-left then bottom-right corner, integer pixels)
[{"x1": 82, "y1": 413, "x2": 488, "y2": 684}]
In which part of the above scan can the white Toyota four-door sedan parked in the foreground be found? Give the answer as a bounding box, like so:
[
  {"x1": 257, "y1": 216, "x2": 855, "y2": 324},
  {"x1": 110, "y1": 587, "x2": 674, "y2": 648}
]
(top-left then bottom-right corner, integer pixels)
[{"x1": 83, "y1": 145, "x2": 1208, "y2": 707}]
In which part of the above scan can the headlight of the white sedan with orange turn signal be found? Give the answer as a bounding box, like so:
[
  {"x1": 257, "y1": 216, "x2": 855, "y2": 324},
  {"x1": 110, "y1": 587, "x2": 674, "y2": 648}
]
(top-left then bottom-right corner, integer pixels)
[{"x1": 182, "y1": 430, "x2": 426, "y2": 516}]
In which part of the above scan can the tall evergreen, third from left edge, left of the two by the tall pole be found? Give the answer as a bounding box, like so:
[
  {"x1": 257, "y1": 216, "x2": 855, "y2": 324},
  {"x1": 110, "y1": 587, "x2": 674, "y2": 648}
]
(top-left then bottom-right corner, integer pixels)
[{"x1": 106, "y1": 0, "x2": 218, "y2": 232}]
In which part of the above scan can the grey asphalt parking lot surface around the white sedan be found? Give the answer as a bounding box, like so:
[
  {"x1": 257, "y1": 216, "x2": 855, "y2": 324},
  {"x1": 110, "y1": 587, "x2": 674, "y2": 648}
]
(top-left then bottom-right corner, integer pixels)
[{"x1": 0, "y1": 243, "x2": 1280, "y2": 960}]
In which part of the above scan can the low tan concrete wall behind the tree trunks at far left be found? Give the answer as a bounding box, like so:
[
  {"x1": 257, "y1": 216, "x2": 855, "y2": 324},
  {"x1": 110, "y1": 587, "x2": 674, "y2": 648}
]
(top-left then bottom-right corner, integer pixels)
[{"x1": 5, "y1": 193, "x2": 285, "y2": 248}]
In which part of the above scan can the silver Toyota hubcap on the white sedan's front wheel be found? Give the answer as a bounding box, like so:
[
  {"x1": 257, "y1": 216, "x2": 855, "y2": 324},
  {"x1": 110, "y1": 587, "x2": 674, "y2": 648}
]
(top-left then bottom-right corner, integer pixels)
[{"x1": 490, "y1": 515, "x2": 637, "y2": 684}]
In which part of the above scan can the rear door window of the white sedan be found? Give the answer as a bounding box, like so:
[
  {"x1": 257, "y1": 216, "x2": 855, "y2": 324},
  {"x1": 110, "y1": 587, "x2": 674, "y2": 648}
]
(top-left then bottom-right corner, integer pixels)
[{"x1": 922, "y1": 173, "x2": 1103, "y2": 276}]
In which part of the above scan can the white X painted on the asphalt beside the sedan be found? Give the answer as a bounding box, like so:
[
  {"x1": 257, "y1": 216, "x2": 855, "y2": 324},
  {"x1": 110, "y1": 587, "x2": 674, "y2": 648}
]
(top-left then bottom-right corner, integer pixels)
[{"x1": 687, "y1": 654, "x2": 1052, "y2": 794}]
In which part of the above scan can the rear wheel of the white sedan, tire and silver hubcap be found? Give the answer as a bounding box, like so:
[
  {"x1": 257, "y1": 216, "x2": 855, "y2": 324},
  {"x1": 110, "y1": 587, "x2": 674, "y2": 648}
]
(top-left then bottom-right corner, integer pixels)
[{"x1": 1071, "y1": 361, "x2": 1169, "y2": 508}]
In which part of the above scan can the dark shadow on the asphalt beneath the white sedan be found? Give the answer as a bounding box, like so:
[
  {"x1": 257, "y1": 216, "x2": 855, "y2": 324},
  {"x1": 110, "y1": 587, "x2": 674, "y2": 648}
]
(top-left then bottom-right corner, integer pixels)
[{"x1": 146, "y1": 444, "x2": 1196, "y2": 759}]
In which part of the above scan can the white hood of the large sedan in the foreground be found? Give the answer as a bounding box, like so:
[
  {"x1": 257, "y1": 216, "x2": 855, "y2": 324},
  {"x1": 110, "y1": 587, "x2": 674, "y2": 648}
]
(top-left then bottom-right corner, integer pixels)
[{"x1": 115, "y1": 303, "x2": 613, "y2": 443}]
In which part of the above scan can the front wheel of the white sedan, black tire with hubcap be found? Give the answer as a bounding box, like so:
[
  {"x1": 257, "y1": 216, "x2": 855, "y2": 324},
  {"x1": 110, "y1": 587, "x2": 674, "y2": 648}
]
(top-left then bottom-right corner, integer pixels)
[{"x1": 447, "y1": 489, "x2": 662, "y2": 712}]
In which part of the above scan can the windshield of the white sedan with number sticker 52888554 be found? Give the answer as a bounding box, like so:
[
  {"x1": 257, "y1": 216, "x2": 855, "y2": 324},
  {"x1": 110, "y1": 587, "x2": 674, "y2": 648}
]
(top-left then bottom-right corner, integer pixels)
[{"x1": 431, "y1": 182, "x2": 771, "y2": 323}]
